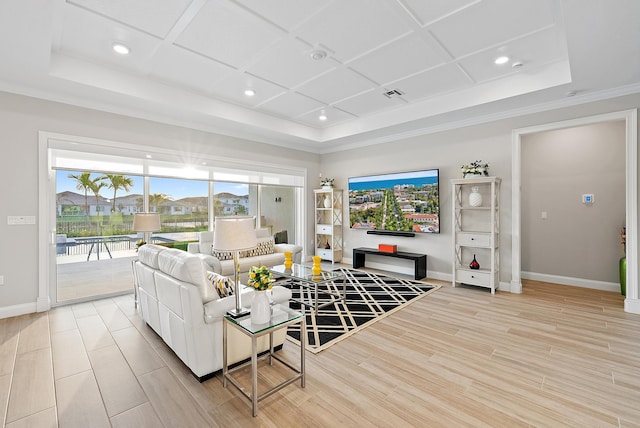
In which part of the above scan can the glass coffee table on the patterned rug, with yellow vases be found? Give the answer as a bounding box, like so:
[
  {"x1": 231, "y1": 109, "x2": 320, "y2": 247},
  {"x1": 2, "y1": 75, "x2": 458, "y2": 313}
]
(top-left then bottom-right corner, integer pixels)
[{"x1": 269, "y1": 263, "x2": 347, "y2": 312}]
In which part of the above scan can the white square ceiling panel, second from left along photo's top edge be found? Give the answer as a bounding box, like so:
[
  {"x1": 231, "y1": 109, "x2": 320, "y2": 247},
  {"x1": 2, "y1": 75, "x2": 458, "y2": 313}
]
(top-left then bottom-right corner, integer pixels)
[{"x1": 176, "y1": 1, "x2": 283, "y2": 68}]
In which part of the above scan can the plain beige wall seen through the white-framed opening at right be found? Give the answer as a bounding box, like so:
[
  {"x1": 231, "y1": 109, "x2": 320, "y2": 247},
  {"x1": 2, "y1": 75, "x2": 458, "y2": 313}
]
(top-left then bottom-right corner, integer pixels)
[{"x1": 521, "y1": 121, "x2": 626, "y2": 288}]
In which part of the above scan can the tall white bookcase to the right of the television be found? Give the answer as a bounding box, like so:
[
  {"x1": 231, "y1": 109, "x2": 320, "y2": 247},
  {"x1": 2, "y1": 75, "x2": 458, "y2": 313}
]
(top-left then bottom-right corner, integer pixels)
[{"x1": 451, "y1": 177, "x2": 502, "y2": 294}]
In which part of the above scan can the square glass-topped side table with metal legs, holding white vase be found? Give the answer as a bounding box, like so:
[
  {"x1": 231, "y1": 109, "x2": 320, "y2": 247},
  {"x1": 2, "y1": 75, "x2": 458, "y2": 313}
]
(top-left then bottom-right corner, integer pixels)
[{"x1": 222, "y1": 305, "x2": 306, "y2": 416}]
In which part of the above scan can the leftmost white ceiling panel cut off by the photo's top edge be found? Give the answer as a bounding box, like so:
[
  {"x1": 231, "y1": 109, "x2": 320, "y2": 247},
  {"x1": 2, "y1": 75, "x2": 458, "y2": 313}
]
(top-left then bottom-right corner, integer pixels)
[{"x1": 67, "y1": 0, "x2": 191, "y2": 37}]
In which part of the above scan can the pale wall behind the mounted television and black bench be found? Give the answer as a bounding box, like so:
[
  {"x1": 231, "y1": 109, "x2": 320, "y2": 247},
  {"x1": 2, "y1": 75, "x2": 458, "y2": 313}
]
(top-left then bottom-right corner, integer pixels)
[{"x1": 322, "y1": 130, "x2": 511, "y2": 281}]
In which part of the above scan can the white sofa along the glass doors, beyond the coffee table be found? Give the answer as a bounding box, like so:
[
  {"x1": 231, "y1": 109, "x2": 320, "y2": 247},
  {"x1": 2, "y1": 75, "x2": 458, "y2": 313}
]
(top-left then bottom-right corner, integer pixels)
[{"x1": 187, "y1": 228, "x2": 302, "y2": 283}]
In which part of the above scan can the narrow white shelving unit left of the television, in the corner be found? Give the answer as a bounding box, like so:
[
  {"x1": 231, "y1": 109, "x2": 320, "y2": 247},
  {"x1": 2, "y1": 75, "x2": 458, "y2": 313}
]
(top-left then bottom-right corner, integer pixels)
[{"x1": 313, "y1": 188, "x2": 343, "y2": 263}]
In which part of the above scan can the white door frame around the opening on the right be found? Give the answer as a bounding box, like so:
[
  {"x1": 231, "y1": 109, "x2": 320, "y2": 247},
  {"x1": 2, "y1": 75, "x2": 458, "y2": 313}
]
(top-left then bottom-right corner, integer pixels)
[{"x1": 511, "y1": 109, "x2": 640, "y2": 314}]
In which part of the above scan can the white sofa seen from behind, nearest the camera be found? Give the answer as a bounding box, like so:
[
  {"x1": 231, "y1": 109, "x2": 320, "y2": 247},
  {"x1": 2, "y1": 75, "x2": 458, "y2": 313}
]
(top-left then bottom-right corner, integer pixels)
[{"x1": 134, "y1": 244, "x2": 291, "y2": 382}]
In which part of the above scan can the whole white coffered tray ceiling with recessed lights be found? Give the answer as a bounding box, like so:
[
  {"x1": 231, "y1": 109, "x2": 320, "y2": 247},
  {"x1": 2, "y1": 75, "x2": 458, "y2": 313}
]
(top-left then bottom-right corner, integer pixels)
[{"x1": 0, "y1": 0, "x2": 640, "y2": 153}]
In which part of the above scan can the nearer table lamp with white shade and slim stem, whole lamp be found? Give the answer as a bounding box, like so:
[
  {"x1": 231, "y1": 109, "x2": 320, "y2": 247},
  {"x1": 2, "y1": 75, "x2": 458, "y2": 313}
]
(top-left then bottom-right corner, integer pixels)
[{"x1": 213, "y1": 216, "x2": 258, "y2": 318}]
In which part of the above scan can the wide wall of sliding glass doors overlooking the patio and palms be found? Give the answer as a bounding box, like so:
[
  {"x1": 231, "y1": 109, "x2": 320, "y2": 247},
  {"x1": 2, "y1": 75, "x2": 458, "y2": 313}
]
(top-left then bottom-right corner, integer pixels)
[{"x1": 40, "y1": 133, "x2": 305, "y2": 302}]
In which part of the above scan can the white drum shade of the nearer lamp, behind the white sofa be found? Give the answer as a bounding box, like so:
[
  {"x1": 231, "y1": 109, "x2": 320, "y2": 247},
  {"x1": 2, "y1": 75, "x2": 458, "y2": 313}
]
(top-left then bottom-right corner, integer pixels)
[{"x1": 213, "y1": 216, "x2": 258, "y2": 251}]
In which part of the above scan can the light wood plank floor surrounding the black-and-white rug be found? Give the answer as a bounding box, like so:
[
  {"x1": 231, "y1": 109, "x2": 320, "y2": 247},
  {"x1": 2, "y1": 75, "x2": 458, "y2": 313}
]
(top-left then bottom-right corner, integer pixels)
[{"x1": 0, "y1": 276, "x2": 640, "y2": 428}]
